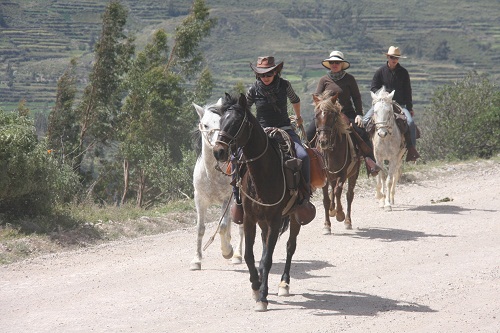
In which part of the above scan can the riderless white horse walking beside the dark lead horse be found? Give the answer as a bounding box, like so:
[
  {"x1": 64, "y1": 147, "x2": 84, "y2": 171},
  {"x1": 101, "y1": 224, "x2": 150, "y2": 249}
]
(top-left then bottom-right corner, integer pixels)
[{"x1": 190, "y1": 99, "x2": 243, "y2": 270}]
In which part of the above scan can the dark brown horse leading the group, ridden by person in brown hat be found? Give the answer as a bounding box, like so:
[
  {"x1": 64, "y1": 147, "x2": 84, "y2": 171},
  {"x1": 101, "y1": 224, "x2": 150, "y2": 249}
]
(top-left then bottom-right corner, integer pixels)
[{"x1": 213, "y1": 94, "x2": 300, "y2": 311}]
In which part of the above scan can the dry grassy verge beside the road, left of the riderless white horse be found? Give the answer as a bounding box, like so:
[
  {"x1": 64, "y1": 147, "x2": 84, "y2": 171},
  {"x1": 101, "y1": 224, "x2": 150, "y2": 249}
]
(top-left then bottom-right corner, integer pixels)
[{"x1": 0, "y1": 200, "x2": 195, "y2": 264}]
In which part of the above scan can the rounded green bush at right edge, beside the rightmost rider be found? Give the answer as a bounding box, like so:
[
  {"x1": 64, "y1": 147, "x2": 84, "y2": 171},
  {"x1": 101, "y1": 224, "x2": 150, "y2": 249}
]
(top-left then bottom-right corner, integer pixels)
[{"x1": 419, "y1": 72, "x2": 500, "y2": 160}]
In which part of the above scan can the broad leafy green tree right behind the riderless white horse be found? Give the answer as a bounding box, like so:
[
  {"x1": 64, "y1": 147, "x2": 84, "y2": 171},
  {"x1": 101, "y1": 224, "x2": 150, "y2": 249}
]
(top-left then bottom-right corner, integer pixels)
[{"x1": 120, "y1": 0, "x2": 215, "y2": 207}]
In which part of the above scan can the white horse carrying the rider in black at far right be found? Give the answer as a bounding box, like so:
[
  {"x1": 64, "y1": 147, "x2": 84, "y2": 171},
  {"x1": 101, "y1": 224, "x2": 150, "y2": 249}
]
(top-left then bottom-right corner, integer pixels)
[{"x1": 371, "y1": 87, "x2": 406, "y2": 211}]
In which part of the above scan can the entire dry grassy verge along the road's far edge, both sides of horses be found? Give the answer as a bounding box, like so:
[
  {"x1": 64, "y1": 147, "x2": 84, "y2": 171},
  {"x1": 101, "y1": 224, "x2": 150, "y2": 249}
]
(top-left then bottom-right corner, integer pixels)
[{"x1": 0, "y1": 155, "x2": 500, "y2": 265}]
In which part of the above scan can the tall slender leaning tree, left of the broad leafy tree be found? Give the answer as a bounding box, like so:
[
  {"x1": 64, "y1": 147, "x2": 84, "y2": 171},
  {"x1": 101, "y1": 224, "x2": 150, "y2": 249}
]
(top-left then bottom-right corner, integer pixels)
[{"x1": 74, "y1": 0, "x2": 134, "y2": 173}]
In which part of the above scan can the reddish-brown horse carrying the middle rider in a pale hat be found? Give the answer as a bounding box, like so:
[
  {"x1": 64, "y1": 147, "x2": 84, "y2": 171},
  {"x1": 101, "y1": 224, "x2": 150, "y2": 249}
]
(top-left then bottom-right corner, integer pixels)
[{"x1": 313, "y1": 91, "x2": 361, "y2": 235}]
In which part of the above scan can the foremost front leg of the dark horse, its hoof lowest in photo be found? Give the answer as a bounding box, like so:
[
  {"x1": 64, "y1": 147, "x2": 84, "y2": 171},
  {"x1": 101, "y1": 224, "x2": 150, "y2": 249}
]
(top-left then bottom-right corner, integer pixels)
[{"x1": 255, "y1": 222, "x2": 281, "y2": 312}]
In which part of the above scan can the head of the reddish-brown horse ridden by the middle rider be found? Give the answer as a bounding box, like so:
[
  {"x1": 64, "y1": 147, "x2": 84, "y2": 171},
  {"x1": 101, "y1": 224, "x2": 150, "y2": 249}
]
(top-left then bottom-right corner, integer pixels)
[{"x1": 313, "y1": 90, "x2": 347, "y2": 150}]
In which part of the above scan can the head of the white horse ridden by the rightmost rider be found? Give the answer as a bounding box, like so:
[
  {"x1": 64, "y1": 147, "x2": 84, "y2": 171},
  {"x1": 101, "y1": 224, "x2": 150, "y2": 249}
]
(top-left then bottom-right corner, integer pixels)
[{"x1": 371, "y1": 86, "x2": 395, "y2": 138}]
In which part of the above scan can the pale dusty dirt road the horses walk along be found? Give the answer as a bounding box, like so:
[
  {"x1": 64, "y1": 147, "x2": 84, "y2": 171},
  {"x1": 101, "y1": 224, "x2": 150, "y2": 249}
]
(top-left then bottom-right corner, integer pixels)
[{"x1": 0, "y1": 162, "x2": 500, "y2": 333}]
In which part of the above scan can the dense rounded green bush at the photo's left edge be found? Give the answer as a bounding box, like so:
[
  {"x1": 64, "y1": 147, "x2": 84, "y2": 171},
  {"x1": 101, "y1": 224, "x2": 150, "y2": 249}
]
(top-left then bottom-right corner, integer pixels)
[{"x1": 0, "y1": 110, "x2": 78, "y2": 215}]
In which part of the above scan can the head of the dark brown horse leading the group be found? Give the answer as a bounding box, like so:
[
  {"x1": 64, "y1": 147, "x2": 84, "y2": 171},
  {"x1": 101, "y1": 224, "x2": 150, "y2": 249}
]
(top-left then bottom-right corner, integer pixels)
[{"x1": 213, "y1": 93, "x2": 251, "y2": 162}]
